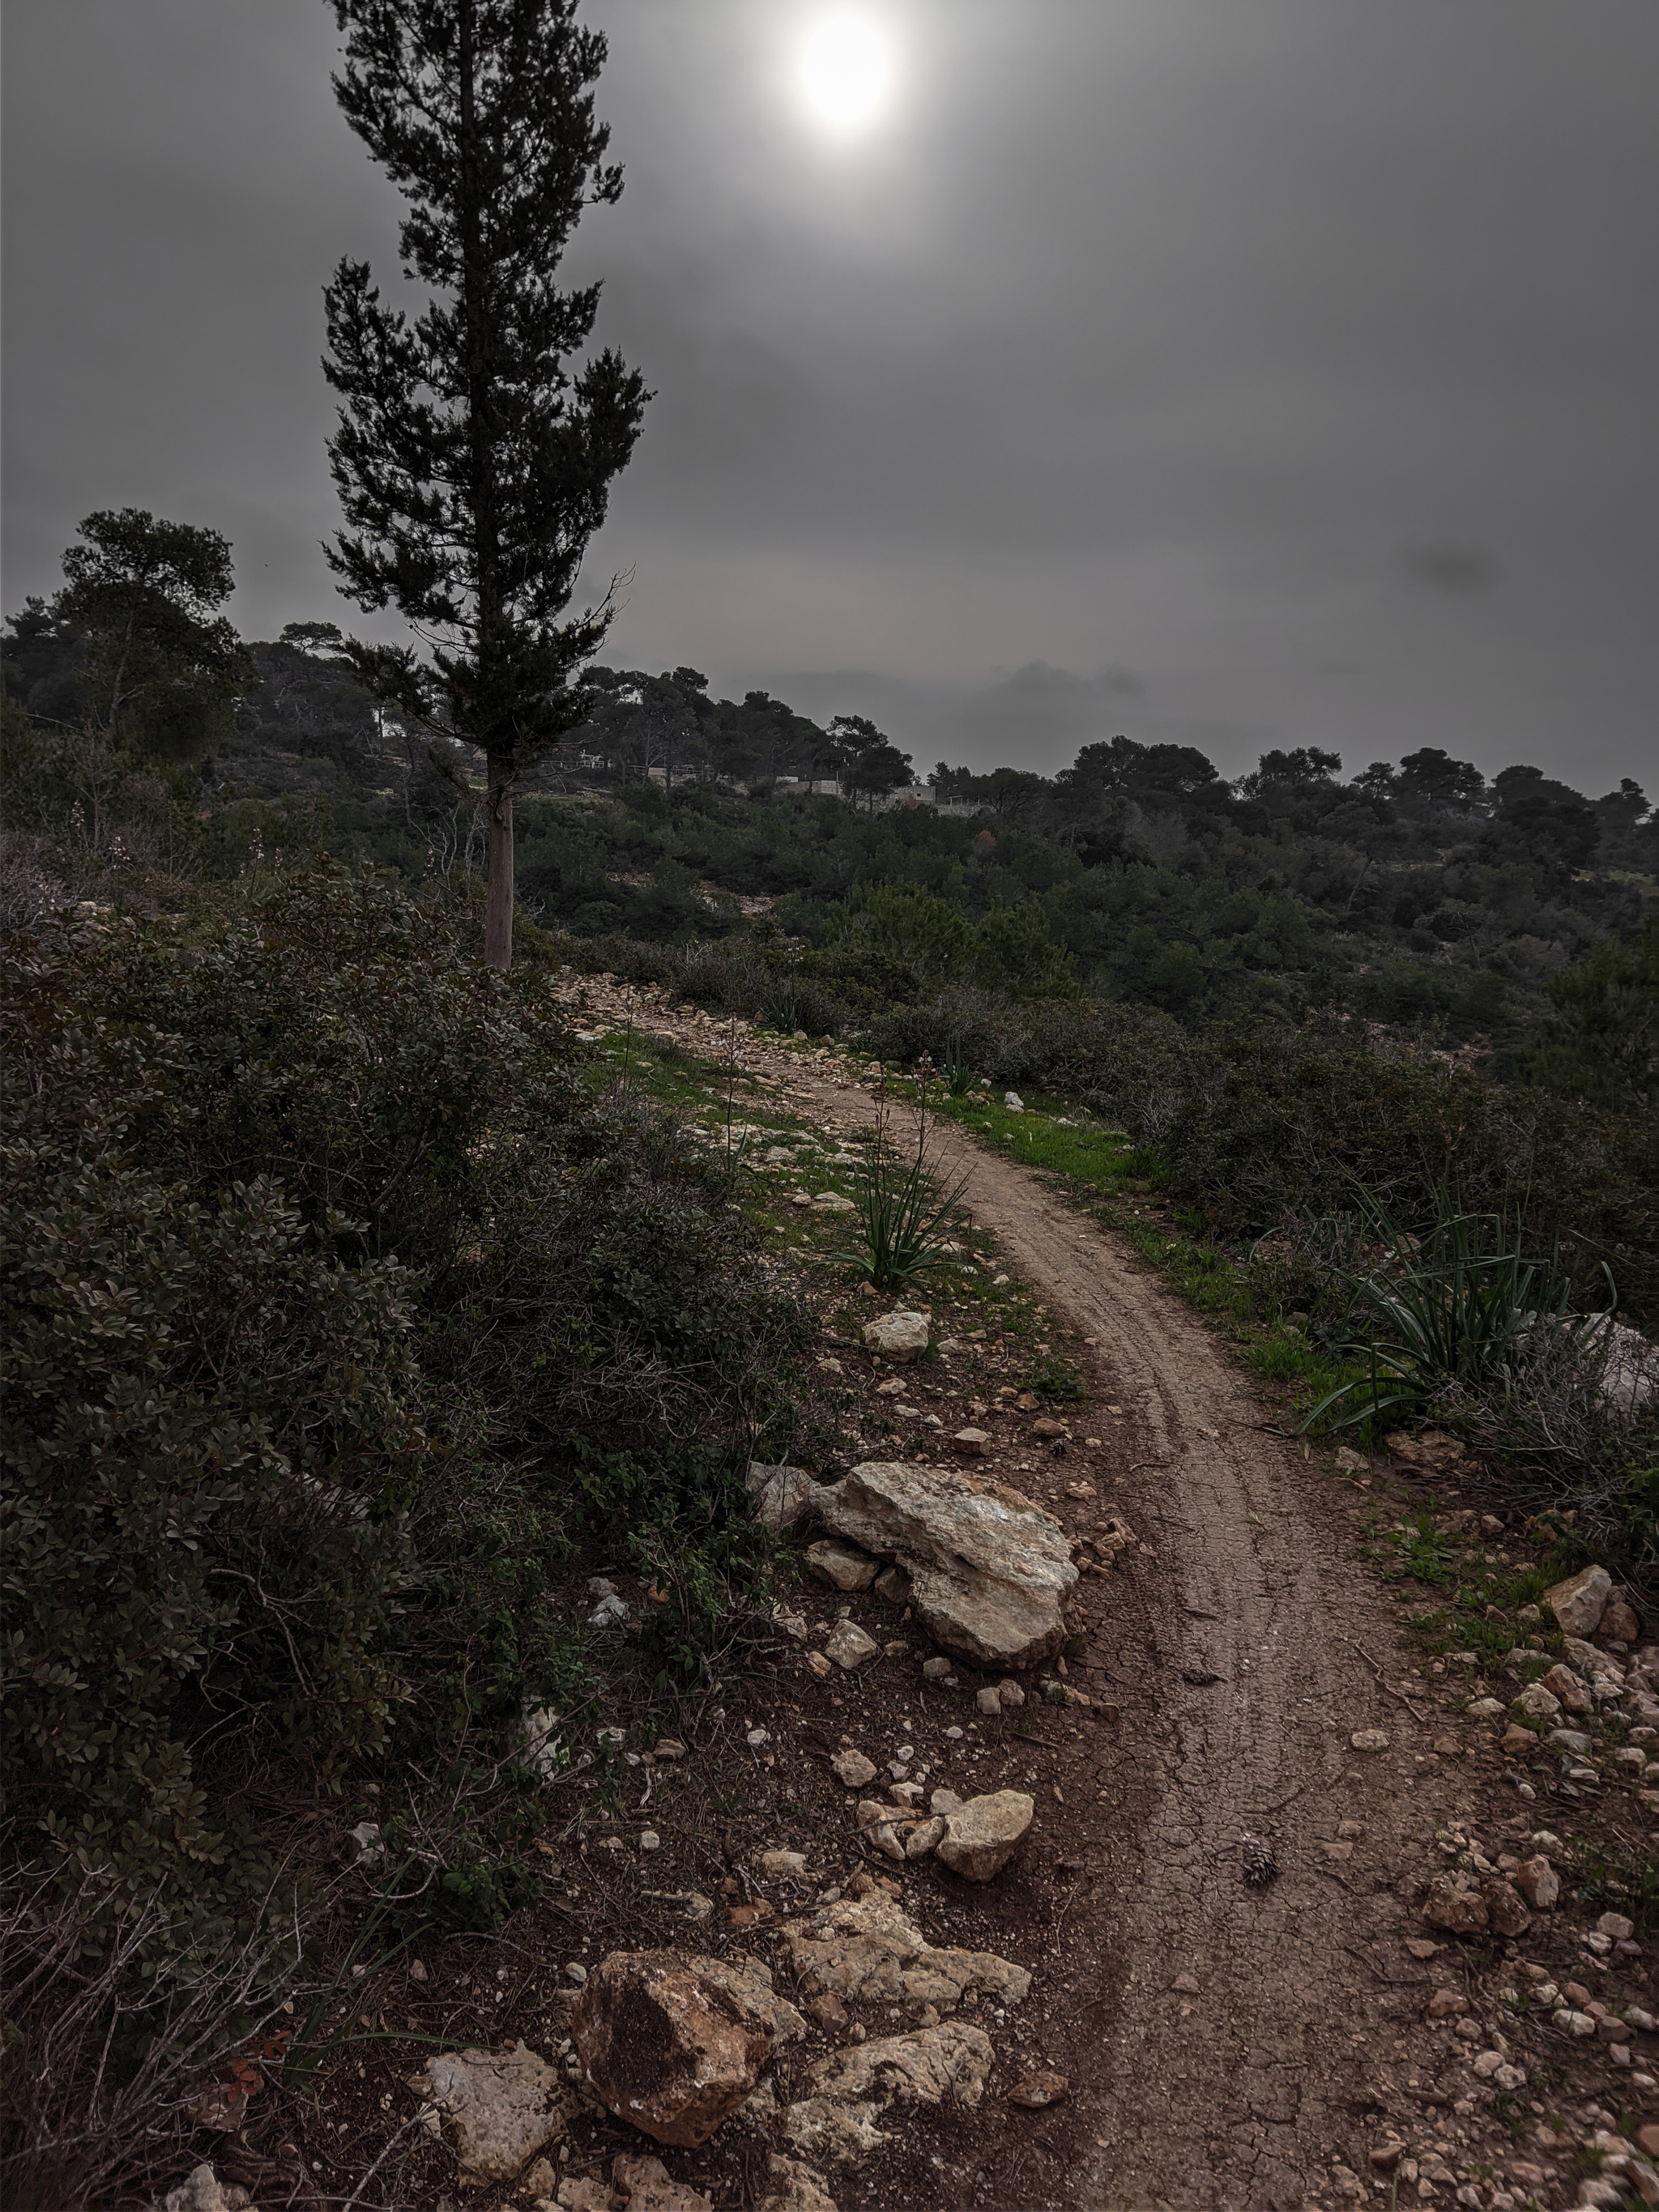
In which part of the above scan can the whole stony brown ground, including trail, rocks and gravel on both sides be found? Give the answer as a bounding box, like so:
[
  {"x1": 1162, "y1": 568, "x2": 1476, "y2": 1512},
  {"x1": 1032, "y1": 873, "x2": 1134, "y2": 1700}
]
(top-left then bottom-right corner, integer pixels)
[{"x1": 168, "y1": 980, "x2": 1659, "y2": 2212}]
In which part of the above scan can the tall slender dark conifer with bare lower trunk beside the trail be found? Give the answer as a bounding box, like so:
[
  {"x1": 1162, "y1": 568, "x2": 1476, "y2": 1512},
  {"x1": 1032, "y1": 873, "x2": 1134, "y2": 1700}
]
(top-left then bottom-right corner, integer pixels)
[{"x1": 323, "y1": 0, "x2": 650, "y2": 969}]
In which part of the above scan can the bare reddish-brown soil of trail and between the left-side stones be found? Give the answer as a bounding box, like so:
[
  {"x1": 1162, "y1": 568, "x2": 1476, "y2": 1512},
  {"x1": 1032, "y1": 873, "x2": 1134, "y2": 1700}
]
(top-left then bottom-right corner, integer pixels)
[{"x1": 201, "y1": 1026, "x2": 1659, "y2": 2212}]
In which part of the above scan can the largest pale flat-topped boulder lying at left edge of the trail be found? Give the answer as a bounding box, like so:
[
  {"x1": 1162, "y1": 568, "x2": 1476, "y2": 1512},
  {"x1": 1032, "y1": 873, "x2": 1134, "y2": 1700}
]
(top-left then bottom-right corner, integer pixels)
[{"x1": 814, "y1": 1460, "x2": 1077, "y2": 1668}]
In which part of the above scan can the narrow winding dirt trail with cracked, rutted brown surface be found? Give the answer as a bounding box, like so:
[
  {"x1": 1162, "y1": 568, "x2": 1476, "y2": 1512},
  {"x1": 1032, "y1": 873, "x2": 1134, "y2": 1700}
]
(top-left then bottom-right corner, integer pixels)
[{"x1": 809, "y1": 1061, "x2": 1422, "y2": 2208}]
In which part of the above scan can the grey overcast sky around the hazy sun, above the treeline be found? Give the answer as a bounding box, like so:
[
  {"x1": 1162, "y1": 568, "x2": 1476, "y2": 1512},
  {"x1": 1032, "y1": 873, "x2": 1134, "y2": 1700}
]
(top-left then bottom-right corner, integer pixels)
[{"x1": 4, "y1": 0, "x2": 1659, "y2": 792}]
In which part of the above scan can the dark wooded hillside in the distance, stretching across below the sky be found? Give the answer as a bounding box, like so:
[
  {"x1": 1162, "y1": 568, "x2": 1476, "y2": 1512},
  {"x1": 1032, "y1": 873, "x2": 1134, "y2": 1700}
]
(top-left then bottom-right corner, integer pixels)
[{"x1": 4, "y1": 531, "x2": 1659, "y2": 1071}]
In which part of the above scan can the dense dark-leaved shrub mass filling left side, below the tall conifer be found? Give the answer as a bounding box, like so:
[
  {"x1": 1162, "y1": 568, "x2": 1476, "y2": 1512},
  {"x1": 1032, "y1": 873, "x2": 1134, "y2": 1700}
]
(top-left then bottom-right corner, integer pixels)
[{"x1": 0, "y1": 869, "x2": 799, "y2": 1895}]
